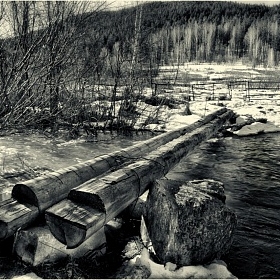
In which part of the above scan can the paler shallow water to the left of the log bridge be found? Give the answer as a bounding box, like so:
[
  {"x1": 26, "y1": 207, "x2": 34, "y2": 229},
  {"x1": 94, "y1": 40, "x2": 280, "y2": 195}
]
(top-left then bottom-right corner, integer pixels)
[{"x1": 0, "y1": 133, "x2": 151, "y2": 190}]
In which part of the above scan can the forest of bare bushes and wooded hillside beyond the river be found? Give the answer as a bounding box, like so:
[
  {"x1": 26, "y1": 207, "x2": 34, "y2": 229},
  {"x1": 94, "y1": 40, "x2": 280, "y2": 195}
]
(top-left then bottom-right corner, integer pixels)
[{"x1": 0, "y1": 1, "x2": 280, "y2": 136}]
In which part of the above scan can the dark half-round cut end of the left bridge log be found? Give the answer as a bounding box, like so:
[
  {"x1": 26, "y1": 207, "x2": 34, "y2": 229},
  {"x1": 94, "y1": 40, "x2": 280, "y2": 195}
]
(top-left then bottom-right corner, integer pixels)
[{"x1": 12, "y1": 184, "x2": 39, "y2": 207}]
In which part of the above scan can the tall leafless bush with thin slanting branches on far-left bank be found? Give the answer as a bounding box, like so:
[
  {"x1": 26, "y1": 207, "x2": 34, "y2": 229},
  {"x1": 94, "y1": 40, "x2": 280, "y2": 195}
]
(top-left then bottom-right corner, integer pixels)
[{"x1": 0, "y1": 1, "x2": 106, "y2": 131}]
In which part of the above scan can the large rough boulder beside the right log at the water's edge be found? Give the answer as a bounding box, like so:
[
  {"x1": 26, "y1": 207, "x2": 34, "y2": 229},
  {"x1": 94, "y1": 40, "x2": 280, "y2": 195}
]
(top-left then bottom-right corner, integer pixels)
[{"x1": 145, "y1": 180, "x2": 237, "y2": 266}]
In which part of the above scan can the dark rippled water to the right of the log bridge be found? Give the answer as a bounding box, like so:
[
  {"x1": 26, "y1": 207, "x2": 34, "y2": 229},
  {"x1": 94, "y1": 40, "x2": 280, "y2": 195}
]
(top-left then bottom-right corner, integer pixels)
[{"x1": 168, "y1": 133, "x2": 280, "y2": 279}]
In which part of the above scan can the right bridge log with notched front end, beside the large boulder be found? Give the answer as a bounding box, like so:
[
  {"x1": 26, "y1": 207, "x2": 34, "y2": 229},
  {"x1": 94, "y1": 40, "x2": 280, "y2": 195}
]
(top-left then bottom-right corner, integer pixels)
[{"x1": 45, "y1": 111, "x2": 233, "y2": 248}]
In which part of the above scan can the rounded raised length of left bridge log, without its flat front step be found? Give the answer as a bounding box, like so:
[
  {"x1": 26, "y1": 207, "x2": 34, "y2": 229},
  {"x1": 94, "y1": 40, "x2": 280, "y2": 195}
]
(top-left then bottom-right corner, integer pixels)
[{"x1": 12, "y1": 108, "x2": 226, "y2": 212}]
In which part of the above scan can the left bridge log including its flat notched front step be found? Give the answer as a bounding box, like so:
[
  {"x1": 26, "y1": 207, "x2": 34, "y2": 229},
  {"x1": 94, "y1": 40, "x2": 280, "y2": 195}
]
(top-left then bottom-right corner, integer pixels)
[{"x1": 0, "y1": 108, "x2": 226, "y2": 241}]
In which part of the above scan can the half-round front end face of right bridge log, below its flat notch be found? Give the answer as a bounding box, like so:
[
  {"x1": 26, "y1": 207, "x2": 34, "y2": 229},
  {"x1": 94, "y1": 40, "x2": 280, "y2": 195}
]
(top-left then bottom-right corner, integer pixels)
[{"x1": 46, "y1": 215, "x2": 87, "y2": 249}]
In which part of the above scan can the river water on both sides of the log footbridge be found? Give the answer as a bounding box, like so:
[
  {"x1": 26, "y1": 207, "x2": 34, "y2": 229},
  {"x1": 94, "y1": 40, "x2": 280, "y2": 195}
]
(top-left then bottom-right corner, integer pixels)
[{"x1": 0, "y1": 133, "x2": 280, "y2": 278}]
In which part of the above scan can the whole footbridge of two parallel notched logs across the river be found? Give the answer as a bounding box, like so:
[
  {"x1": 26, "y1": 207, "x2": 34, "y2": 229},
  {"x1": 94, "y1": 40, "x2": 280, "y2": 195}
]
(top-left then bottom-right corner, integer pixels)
[{"x1": 0, "y1": 108, "x2": 234, "y2": 248}]
